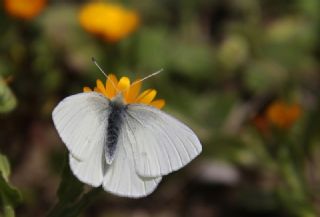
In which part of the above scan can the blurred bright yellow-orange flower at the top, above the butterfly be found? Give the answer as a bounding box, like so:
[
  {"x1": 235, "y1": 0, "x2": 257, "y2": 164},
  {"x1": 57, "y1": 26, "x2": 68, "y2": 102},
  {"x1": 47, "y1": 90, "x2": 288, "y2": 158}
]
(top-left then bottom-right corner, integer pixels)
[{"x1": 79, "y1": 2, "x2": 139, "y2": 42}]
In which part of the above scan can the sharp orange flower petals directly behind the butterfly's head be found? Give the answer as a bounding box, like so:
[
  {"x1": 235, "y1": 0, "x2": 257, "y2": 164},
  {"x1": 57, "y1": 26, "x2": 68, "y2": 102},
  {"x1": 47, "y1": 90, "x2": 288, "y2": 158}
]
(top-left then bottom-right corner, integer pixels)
[{"x1": 83, "y1": 74, "x2": 165, "y2": 109}]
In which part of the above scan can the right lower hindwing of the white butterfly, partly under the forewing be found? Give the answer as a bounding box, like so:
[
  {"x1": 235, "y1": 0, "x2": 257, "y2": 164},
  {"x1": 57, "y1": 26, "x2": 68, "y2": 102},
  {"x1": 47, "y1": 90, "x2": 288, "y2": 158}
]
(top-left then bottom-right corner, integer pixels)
[{"x1": 103, "y1": 125, "x2": 161, "y2": 198}]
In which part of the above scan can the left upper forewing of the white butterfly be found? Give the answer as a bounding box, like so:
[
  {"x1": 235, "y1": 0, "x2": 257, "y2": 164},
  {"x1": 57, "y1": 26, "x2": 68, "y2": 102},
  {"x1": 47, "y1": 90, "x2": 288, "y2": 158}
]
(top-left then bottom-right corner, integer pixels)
[{"x1": 52, "y1": 92, "x2": 109, "y2": 160}]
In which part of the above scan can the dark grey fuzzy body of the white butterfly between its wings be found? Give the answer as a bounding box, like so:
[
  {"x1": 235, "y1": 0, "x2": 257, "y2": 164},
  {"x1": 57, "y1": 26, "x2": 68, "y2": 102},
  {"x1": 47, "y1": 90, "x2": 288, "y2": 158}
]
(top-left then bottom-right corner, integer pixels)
[{"x1": 105, "y1": 102, "x2": 126, "y2": 161}]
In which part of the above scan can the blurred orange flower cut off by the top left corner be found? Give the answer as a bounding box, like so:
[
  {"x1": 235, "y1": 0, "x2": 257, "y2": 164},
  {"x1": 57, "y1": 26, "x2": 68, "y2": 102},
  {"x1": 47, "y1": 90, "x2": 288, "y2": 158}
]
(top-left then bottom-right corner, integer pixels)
[{"x1": 4, "y1": 0, "x2": 47, "y2": 20}]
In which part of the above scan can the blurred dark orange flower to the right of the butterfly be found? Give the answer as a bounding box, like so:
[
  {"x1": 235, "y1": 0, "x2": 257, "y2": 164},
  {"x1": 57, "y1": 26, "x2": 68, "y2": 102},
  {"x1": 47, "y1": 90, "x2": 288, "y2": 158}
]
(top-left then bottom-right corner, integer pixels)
[{"x1": 266, "y1": 101, "x2": 301, "y2": 129}]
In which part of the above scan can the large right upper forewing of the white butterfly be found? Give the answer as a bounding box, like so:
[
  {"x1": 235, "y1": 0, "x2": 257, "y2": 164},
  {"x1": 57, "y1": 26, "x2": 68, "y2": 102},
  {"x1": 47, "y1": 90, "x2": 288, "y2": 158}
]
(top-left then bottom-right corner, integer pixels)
[{"x1": 124, "y1": 104, "x2": 202, "y2": 177}]
